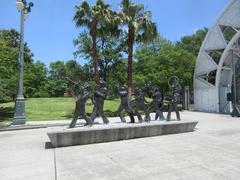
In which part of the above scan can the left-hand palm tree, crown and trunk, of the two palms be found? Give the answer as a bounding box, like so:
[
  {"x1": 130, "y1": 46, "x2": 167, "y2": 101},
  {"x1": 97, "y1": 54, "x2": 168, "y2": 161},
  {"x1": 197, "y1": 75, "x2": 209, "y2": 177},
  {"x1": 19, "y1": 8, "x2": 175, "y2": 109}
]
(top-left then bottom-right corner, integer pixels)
[{"x1": 73, "y1": 0, "x2": 111, "y2": 86}]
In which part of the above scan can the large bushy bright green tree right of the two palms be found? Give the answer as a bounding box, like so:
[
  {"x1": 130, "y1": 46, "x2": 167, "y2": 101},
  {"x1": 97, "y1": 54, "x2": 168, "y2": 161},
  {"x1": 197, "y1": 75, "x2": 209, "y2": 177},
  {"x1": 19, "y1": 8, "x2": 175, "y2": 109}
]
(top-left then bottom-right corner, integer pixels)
[{"x1": 133, "y1": 38, "x2": 196, "y2": 90}]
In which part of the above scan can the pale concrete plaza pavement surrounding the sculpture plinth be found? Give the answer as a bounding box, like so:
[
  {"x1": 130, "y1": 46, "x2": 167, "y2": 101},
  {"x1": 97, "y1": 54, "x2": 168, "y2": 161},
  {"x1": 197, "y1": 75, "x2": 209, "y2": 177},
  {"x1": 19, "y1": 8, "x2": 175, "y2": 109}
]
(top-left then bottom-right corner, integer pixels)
[{"x1": 0, "y1": 112, "x2": 240, "y2": 180}]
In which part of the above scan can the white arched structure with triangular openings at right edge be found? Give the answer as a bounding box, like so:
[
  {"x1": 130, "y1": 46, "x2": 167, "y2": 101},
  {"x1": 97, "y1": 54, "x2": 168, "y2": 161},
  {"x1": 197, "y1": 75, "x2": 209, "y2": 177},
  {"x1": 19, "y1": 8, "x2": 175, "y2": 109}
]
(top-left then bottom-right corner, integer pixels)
[{"x1": 194, "y1": 0, "x2": 240, "y2": 113}]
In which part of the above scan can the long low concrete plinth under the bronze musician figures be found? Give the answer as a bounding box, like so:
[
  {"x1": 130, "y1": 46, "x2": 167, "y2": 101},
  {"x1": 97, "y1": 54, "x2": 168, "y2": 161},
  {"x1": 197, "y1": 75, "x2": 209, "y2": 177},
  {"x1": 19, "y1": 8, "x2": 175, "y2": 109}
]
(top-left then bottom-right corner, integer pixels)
[{"x1": 47, "y1": 121, "x2": 198, "y2": 147}]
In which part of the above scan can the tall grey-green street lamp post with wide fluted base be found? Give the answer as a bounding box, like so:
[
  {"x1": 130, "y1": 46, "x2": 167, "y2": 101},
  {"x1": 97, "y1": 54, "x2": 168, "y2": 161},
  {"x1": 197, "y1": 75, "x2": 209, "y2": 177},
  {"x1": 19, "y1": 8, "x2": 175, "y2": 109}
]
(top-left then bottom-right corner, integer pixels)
[{"x1": 12, "y1": 0, "x2": 33, "y2": 125}]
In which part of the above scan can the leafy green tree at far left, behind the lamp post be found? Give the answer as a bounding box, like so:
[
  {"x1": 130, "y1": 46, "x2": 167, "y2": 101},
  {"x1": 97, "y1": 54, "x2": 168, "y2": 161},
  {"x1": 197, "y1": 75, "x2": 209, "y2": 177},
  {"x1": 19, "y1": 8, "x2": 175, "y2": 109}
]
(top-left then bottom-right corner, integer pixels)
[{"x1": 0, "y1": 29, "x2": 33, "y2": 102}]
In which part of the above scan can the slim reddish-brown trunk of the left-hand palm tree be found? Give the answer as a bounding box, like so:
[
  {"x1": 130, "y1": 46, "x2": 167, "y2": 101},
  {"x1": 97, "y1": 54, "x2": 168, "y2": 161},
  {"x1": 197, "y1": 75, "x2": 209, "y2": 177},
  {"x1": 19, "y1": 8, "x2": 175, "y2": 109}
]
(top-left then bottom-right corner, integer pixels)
[{"x1": 92, "y1": 25, "x2": 100, "y2": 87}]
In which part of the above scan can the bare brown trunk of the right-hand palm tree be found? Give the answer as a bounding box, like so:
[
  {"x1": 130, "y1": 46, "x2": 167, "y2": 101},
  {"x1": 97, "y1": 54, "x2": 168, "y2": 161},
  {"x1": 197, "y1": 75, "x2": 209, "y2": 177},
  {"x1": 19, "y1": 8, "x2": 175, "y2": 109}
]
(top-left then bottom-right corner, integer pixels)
[{"x1": 128, "y1": 28, "x2": 134, "y2": 102}]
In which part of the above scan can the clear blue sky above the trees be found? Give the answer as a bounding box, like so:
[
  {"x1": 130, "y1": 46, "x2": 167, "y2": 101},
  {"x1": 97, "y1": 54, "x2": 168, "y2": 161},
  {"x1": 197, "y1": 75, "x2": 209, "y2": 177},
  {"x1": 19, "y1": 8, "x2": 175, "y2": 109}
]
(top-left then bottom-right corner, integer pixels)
[{"x1": 0, "y1": 0, "x2": 230, "y2": 65}]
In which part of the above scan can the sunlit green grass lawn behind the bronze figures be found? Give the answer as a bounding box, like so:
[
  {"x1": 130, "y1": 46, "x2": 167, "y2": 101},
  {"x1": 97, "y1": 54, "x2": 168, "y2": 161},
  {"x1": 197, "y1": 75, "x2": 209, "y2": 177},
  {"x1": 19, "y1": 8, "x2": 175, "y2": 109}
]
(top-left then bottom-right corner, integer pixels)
[{"x1": 0, "y1": 98, "x2": 181, "y2": 122}]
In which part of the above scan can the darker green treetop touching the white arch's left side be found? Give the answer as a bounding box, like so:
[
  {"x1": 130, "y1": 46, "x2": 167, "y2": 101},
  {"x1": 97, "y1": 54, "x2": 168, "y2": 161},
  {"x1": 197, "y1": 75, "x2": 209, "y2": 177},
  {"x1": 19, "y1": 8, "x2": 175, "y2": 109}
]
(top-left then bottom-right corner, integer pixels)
[{"x1": 177, "y1": 28, "x2": 208, "y2": 57}]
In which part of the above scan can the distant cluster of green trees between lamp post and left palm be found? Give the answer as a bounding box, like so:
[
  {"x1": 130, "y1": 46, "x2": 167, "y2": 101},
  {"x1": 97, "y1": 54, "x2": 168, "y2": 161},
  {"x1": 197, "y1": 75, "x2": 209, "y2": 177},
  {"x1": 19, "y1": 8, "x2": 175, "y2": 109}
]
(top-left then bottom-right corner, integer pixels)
[{"x1": 28, "y1": 60, "x2": 85, "y2": 97}]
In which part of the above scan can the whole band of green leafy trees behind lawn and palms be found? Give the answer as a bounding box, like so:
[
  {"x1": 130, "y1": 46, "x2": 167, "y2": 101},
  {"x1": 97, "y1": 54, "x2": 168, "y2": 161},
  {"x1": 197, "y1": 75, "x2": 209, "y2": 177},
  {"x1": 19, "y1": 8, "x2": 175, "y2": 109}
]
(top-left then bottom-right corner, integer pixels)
[{"x1": 0, "y1": 28, "x2": 207, "y2": 102}]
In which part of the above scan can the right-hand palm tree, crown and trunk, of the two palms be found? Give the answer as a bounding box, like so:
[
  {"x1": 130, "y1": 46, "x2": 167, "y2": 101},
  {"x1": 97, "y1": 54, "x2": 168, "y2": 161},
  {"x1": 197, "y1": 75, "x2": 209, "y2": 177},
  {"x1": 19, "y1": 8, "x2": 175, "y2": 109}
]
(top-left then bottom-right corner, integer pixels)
[{"x1": 120, "y1": 0, "x2": 157, "y2": 99}]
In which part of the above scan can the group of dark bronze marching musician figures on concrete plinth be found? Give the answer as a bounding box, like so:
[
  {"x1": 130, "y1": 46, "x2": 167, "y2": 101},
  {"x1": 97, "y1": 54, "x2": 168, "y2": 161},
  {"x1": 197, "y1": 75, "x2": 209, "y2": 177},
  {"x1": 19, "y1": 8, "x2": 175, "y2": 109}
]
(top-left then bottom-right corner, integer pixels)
[{"x1": 68, "y1": 76, "x2": 182, "y2": 128}]
